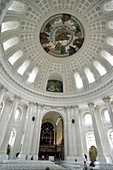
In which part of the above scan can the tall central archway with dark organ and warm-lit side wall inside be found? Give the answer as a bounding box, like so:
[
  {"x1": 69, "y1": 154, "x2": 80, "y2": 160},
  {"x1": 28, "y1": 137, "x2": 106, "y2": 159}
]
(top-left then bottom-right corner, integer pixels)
[{"x1": 39, "y1": 111, "x2": 64, "y2": 161}]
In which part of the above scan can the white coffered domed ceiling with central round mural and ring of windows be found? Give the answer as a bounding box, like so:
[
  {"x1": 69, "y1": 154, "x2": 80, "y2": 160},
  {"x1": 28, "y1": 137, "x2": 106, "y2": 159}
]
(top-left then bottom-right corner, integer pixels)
[{"x1": 0, "y1": 0, "x2": 113, "y2": 105}]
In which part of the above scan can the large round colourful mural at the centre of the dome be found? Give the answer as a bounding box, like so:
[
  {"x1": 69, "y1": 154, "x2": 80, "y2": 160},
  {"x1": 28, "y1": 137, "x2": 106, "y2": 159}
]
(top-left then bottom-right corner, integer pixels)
[{"x1": 40, "y1": 14, "x2": 84, "y2": 57}]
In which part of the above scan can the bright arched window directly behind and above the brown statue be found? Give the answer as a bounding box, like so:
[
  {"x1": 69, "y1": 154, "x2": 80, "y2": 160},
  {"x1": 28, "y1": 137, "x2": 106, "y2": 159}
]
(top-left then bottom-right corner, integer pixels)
[{"x1": 86, "y1": 132, "x2": 96, "y2": 150}]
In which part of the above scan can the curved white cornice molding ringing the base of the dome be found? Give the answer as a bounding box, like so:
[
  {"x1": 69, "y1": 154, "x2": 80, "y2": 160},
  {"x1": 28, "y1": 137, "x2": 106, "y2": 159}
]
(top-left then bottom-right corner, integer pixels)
[{"x1": 0, "y1": 60, "x2": 113, "y2": 103}]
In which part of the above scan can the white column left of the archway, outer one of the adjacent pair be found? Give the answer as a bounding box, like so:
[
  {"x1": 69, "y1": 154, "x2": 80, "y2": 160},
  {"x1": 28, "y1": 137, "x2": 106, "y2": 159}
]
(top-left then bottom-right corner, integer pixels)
[{"x1": 20, "y1": 103, "x2": 34, "y2": 159}]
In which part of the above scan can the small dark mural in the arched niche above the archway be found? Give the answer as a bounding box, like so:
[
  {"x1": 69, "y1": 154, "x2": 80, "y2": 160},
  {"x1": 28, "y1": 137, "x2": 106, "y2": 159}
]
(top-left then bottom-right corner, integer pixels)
[{"x1": 46, "y1": 80, "x2": 63, "y2": 93}]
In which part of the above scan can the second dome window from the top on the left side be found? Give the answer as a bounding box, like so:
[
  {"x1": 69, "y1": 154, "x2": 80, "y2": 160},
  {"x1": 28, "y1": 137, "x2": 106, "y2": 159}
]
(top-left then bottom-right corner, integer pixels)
[{"x1": 1, "y1": 21, "x2": 19, "y2": 32}]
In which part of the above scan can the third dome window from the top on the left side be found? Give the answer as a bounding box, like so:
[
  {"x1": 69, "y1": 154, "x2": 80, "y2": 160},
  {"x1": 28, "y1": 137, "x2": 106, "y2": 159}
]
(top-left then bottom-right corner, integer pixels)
[{"x1": 3, "y1": 37, "x2": 19, "y2": 51}]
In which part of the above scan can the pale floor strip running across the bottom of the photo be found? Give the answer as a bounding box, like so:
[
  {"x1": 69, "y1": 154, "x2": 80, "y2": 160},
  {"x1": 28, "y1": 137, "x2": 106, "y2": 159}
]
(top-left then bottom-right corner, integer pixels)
[{"x1": 0, "y1": 160, "x2": 113, "y2": 170}]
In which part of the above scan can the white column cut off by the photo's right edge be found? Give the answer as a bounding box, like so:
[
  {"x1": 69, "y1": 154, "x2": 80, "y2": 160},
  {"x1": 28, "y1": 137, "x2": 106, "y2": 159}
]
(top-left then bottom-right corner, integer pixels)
[{"x1": 103, "y1": 97, "x2": 113, "y2": 127}]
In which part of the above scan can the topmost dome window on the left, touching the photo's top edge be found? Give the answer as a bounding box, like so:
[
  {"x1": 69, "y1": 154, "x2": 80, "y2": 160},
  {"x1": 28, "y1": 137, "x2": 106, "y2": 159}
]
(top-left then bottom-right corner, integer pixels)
[{"x1": 8, "y1": 1, "x2": 25, "y2": 13}]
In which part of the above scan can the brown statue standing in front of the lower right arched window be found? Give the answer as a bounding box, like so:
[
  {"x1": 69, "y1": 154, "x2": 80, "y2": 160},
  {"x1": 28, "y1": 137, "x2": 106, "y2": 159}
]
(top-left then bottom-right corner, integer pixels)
[{"x1": 89, "y1": 146, "x2": 97, "y2": 161}]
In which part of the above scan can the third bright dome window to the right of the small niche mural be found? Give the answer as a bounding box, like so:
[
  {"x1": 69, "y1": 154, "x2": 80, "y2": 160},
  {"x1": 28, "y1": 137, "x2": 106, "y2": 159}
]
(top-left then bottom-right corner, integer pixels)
[{"x1": 94, "y1": 61, "x2": 107, "y2": 76}]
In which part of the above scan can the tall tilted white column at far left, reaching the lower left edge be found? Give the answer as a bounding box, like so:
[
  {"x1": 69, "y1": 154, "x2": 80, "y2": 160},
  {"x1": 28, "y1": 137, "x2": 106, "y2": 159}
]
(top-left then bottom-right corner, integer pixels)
[{"x1": 0, "y1": 96, "x2": 20, "y2": 160}]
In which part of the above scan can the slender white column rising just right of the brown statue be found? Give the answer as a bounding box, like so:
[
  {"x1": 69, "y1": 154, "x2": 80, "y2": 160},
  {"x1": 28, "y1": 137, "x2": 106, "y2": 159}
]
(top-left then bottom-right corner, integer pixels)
[{"x1": 88, "y1": 103, "x2": 105, "y2": 161}]
